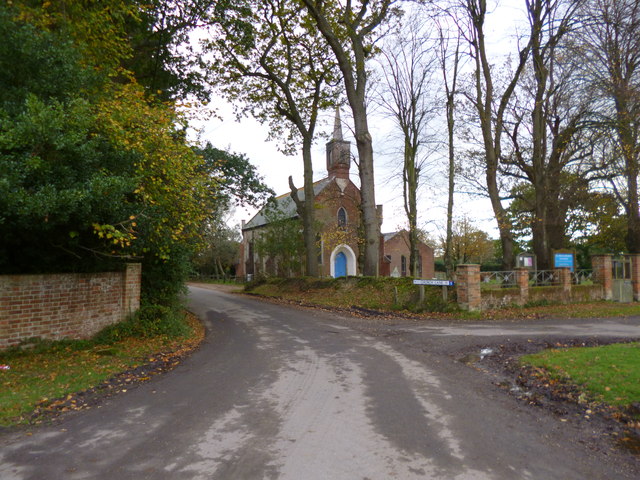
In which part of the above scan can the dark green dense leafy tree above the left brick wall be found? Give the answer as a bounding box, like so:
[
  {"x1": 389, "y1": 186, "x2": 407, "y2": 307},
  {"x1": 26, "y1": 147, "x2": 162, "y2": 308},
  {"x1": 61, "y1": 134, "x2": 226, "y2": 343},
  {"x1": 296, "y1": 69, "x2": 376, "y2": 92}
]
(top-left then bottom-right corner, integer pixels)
[{"x1": 0, "y1": 6, "x2": 135, "y2": 273}]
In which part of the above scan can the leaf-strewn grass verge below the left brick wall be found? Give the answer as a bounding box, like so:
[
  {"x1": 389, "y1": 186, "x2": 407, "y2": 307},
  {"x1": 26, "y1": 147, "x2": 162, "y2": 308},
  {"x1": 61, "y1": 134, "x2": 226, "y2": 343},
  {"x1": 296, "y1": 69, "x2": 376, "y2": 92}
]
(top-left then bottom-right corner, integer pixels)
[{"x1": 0, "y1": 314, "x2": 204, "y2": 426}]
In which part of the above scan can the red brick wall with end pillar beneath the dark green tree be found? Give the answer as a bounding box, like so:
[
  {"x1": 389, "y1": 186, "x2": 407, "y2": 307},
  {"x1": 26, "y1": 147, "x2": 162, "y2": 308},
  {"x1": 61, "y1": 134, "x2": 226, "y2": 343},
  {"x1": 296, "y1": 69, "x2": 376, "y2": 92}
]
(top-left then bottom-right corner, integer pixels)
[{"x1": 0, "y1": 264, "x2": 141, "y2": 349}]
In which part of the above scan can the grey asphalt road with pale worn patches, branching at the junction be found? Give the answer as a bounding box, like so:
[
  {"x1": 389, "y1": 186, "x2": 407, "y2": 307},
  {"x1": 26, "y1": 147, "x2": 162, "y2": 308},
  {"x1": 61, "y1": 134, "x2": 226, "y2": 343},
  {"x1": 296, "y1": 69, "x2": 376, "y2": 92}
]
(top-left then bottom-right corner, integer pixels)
[{"x1": 0, "y1": 287, "x2": 640, "y2": 480}]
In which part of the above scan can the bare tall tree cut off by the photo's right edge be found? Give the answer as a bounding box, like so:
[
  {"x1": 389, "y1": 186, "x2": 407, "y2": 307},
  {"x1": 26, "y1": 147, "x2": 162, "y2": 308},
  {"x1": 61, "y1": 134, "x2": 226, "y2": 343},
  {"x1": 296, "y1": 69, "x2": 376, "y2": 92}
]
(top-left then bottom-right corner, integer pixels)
[{"x1": 577, "y1": 0, "x2": 640, "y2": 253}]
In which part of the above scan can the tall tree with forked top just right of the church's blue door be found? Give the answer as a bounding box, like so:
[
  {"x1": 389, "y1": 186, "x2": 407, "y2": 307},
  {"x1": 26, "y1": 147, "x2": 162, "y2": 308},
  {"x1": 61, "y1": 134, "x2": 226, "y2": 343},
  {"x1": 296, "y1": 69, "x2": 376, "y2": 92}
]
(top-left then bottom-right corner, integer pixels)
[{"x1": 299, "y1": 0, "x2": 396, "y2": 276}]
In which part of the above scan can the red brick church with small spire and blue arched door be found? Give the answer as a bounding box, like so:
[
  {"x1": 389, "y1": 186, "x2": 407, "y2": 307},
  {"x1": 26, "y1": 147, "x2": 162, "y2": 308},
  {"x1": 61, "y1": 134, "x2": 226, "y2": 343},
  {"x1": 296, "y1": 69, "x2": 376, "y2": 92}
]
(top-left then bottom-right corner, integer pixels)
[{"x1": 236, "y1": 112, "x2": 434, "y2": 278}]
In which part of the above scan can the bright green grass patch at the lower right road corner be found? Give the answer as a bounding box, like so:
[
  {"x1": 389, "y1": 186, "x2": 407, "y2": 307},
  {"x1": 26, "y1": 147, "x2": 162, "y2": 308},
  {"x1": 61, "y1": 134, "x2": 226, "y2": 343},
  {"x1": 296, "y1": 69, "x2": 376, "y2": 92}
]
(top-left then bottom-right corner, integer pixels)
[{"x1": 520, "y1": 342, "x2": 640, "y2": 407}]
